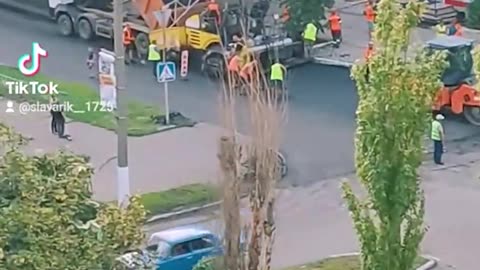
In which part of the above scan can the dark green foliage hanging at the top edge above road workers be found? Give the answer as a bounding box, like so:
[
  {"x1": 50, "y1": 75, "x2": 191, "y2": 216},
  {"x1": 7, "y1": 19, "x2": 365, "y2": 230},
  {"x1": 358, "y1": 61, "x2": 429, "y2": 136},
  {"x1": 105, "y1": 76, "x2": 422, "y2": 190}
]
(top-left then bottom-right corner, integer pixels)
[{"x1": 280, "y1": 0, "x2": 335, "y2": 34}]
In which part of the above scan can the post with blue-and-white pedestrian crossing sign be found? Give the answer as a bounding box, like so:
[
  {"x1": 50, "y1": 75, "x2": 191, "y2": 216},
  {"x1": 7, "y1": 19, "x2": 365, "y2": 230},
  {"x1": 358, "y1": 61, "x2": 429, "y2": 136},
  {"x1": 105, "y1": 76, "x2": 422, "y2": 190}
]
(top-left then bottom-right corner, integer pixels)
[{"x1": 154, "y1": 8, "x2": 176, "y2": 125}]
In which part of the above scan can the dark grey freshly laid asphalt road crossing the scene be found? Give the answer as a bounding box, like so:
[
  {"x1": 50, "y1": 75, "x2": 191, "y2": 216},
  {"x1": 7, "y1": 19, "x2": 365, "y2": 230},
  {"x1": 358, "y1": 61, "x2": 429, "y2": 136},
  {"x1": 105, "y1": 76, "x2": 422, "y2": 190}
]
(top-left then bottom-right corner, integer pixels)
[{"x1": 0, "y1": 9, "x2": 475, "y2": 185}]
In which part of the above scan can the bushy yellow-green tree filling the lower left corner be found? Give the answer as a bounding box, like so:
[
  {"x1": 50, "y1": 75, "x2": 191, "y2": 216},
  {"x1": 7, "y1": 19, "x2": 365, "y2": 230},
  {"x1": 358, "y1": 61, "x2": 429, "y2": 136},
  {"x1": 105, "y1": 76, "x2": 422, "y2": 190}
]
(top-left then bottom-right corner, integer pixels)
[{"x1": 0, "y1": 124, "x2": 145, "y2": 270}]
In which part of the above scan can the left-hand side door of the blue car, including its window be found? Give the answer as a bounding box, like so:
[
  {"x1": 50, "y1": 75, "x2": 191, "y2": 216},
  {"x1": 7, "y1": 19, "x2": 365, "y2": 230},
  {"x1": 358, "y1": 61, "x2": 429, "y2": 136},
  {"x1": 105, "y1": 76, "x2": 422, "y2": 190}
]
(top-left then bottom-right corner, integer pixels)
[{"x1": 158, "y1": 241, "x2": 193, "y2": 270}]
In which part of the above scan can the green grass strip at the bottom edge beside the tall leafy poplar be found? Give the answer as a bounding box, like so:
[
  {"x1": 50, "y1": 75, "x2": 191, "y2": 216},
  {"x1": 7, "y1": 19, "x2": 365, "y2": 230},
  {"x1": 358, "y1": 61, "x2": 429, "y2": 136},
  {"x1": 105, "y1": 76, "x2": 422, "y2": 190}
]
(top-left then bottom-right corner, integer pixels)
[{"x1": 284, "y1": 256, "x2": 427, "y2": 270}]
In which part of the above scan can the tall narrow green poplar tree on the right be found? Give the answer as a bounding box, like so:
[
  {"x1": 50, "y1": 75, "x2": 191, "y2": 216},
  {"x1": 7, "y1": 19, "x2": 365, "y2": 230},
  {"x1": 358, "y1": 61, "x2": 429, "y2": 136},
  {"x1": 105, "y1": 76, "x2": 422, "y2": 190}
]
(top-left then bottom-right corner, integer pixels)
[{"x1": 343, "y1": 0, "x2": 446, "y2": 270}]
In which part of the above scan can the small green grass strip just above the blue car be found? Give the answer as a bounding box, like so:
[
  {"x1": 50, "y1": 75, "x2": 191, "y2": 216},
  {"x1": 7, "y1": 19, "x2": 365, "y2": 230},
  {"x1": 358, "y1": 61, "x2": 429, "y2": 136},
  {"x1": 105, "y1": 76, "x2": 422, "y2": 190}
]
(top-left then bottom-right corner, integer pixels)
[{"x1": 141, "y1": 184, "x2": 219, "y2": 216}]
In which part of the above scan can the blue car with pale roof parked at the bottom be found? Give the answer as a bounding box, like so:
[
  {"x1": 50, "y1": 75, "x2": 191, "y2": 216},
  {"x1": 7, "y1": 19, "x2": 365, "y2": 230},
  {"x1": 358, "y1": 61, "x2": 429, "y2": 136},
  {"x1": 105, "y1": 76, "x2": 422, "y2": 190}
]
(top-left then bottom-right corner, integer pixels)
[{"x1": 146, "y1": 228, "x2": 223, "y2": 270}]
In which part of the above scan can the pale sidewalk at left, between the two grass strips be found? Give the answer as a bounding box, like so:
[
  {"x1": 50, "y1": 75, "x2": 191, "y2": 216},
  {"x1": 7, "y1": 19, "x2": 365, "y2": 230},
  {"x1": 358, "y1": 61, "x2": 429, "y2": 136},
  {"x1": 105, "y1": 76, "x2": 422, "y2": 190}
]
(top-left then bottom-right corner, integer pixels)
[{"x1": 0, "y1": 100, "x2": 246, "y2": 201}]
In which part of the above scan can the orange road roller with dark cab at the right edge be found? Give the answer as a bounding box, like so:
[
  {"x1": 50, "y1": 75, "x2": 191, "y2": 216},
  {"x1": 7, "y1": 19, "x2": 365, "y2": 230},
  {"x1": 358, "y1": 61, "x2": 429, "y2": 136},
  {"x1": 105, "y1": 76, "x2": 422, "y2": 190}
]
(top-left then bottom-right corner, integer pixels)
[{"x1": 427, "y1": 36, "x2": 480, "y2": 126}]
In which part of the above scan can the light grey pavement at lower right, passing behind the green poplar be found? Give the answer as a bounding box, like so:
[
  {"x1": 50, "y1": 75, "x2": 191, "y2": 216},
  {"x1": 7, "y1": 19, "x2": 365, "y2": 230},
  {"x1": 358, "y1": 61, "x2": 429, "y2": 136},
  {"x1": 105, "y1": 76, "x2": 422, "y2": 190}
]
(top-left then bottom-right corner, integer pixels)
[{"x1": 147, "y1": 147, "x2": 480, "y2": 270}]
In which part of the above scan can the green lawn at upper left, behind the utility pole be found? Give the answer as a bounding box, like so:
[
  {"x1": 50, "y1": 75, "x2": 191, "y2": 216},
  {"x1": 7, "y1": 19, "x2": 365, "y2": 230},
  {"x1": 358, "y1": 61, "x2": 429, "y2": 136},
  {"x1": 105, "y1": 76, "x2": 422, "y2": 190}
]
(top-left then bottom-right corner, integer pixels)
[{"x1": 0, "y1": 65, "x2": 163, "y2": 136}]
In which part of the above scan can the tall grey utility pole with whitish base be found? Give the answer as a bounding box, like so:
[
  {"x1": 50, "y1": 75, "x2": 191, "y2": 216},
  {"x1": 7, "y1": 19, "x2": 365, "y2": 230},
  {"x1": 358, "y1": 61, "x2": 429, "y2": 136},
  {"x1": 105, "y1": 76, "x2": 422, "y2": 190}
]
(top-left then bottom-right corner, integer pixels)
[{"x1": 113, "y1": 0, "x2": 130, "y2": 207}]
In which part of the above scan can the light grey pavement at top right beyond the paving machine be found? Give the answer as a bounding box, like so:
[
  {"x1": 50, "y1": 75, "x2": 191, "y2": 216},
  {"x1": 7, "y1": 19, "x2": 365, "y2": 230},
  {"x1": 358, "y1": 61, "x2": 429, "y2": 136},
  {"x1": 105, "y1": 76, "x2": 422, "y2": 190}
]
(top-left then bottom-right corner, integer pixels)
[{"x1": 315, "y1": 1, "x2": 480, "y2": 67}]
